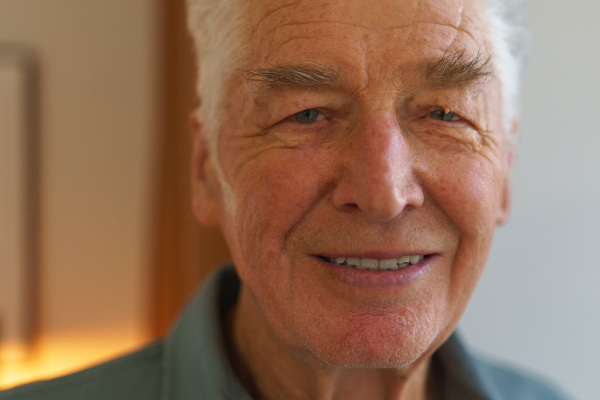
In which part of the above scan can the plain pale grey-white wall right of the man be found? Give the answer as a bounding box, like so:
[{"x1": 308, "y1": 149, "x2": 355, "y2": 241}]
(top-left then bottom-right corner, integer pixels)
[{"x1": 461, "y1": 0, "x2": 600, "y2": 400}]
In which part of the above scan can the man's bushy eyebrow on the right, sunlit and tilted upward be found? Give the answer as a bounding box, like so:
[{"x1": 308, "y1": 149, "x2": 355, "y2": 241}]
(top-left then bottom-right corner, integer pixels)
[{"x1": 421, "y1": 50, "x2": 493, "y2": 89}]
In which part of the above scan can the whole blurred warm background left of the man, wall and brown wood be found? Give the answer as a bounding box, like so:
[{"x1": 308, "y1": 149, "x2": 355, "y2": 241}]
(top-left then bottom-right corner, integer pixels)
[{"x1": 0, "y1": 0, "x2": 227, "y2": 387}]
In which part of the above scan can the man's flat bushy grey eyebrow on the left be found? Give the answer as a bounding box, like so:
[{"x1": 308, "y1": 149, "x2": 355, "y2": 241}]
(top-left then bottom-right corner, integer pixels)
[{"x1": 242, "y1": 64, "x2": 338, "y2": 95}]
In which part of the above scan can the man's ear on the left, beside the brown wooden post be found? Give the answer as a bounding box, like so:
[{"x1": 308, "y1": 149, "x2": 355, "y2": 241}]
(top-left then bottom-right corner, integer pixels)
[{"x1": 190, "y1": 112, "x2": 219, "y2": 226}]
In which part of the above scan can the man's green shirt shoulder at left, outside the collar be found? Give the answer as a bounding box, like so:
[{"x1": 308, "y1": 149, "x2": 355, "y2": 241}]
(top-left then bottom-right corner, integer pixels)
[{"x1": 0, "y1": 342, "x2": 163, "y2": 400}]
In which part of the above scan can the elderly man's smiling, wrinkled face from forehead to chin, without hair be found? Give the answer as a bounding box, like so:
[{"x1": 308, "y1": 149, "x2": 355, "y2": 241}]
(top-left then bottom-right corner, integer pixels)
[{"x1": 195, "y1": 0, "x2": 511, "y2": 367}]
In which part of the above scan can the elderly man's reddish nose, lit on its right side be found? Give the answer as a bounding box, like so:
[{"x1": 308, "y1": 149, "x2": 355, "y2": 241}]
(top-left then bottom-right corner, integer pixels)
[{"x1": 333, "y1": 115, "x2": 424, "y2": 222}]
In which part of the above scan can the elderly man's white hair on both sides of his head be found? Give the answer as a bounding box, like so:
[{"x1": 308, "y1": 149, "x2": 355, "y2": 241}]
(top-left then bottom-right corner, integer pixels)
[{"x1": 187, "y1": 0, "x2": 529, "y2": 147}]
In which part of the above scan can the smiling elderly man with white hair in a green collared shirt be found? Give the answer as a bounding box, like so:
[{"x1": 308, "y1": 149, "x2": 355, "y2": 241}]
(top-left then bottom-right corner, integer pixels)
[{"x1": 0, "y1": 0, "x2": 559, "y2": 400}]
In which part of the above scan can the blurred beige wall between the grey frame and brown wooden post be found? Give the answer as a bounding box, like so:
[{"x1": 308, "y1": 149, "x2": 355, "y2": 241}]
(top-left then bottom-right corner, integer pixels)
[{"x1": 0, "y1": 0, "x2": 160, "y2": 386}]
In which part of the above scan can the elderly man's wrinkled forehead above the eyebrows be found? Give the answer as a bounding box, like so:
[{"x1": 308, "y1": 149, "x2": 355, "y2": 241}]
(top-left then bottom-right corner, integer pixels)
[{"x1": 249, "y1": 0, "x2": 489, "y2": 67}]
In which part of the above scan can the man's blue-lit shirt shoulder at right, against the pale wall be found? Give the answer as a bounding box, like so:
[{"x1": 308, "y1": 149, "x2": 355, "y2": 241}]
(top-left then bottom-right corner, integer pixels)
[{"x1": 475, "y1": 357, "x2": 567, "y2": 400}]
